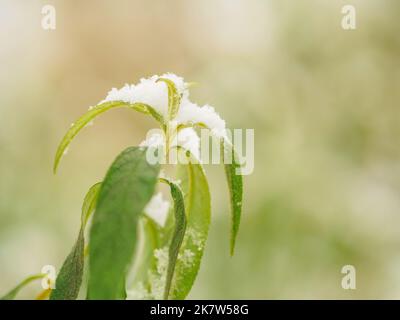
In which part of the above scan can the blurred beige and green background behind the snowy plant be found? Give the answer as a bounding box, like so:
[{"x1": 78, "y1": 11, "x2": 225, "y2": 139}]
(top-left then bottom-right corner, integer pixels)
[{"x1": 0, "y1": 0, "x2": 400, "y2": 299}]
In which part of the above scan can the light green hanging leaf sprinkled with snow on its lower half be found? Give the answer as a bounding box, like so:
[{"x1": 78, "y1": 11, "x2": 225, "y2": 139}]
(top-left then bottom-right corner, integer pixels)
[{"x1": 170, "y1": 162, "x2": 211, "y2": 300}]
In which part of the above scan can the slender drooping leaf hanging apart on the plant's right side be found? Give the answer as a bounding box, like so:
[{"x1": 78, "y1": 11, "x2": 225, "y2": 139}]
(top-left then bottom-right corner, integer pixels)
[{"x1": 222, "y1": 139, "x2": 243, "y2": 255}]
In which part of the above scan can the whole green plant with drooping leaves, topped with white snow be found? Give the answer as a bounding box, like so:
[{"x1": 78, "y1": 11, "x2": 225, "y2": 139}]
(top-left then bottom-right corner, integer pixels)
[{"x1": 1, "y1": 73, "x2": 242, "y2": 299}]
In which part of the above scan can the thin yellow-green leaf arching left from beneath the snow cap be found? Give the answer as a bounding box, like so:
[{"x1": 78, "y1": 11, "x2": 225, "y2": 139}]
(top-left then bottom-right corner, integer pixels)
[{"x1": 53, "y1": 101, "x2": 164, "y2": 173}]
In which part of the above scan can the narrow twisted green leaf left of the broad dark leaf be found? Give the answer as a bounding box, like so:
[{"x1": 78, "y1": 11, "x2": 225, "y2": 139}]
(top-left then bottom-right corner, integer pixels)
[{"x1": 50, "y1": 182, "x2": 101, "y2": 300}]
